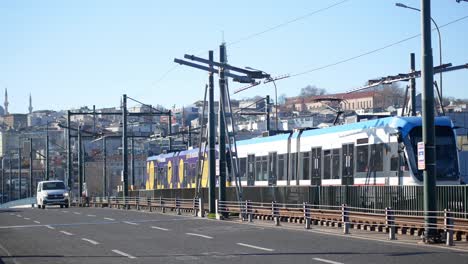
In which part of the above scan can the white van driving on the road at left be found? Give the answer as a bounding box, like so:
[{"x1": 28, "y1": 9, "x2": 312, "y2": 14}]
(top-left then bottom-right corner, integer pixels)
[{"x1": 36, "y1": 181, "x2": 69, "y2": 209}]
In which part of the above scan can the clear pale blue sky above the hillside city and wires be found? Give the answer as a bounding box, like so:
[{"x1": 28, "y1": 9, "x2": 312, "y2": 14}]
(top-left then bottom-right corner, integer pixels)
[{"x1": 0, "y1": 0, "x2": 468, "y2": 113}]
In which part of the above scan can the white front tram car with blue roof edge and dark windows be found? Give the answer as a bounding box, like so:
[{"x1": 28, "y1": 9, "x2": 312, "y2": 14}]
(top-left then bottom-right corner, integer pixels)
[{"x1": 231, "y1": 117, "x2": 460, "y2": 186}]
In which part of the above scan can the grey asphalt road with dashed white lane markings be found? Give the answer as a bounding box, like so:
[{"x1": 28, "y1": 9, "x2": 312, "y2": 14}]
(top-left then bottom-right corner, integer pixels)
[{"x1": 0, "y1": 208, "x2": 468, "y2": 264}]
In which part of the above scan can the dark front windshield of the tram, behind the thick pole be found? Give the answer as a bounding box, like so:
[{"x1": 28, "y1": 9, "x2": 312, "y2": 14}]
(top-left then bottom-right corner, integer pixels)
[{"x1": 409, "y1": 126, "x2": 459, "y2": 180}]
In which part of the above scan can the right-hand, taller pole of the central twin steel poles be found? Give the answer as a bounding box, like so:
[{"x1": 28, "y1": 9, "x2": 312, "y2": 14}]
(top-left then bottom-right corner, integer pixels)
[{"x1": 218, "y1": 43, "x2": 226, "y2": 208}]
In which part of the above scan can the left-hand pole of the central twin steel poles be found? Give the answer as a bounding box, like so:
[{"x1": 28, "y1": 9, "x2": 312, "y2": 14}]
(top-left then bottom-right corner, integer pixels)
[{"x1": 208, "y1": 50, "x2": 216, "y2": 214}]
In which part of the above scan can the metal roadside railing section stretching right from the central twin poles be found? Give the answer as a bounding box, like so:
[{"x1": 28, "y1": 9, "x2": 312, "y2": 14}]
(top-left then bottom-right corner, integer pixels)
[{"x1": 217, "y1": 201, "x2": 468, "y2": 245}]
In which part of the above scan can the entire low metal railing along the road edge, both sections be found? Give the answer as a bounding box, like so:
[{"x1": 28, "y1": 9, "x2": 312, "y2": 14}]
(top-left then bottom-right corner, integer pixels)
[{"x1": 89, "y1": 197, "x2": 468, "y2": 245}]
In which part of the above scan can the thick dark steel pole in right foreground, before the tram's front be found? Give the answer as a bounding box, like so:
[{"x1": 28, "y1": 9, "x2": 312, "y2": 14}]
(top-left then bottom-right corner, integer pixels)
[{"x1": 421, "y1": 0, "x2": 438, "y2": 243}]
